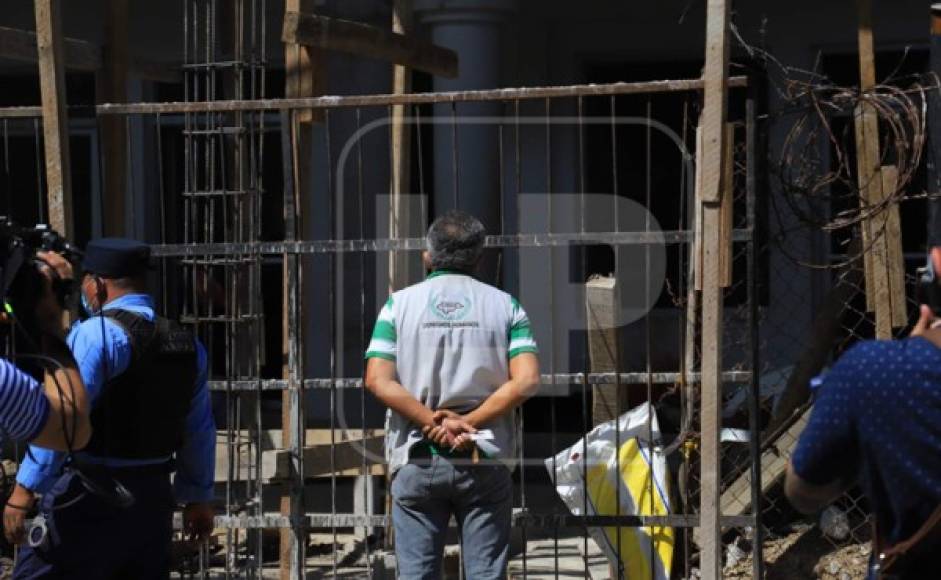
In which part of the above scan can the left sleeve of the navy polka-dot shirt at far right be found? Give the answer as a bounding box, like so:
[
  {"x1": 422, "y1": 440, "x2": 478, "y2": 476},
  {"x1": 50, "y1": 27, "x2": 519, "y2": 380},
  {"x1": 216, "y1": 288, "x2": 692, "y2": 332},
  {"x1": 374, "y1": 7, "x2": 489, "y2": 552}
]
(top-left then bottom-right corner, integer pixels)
[{"x1": 791, "y1": 345, "x2": 869, "y2": 485}]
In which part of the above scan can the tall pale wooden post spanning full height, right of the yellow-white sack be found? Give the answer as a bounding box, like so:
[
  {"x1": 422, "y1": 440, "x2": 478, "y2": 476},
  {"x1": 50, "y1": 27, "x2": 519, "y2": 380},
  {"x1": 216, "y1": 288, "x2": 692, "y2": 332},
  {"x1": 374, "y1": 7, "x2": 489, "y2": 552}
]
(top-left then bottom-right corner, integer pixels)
[{"x1": 696, "y1": 0, "x2": 730, "y2": 580}]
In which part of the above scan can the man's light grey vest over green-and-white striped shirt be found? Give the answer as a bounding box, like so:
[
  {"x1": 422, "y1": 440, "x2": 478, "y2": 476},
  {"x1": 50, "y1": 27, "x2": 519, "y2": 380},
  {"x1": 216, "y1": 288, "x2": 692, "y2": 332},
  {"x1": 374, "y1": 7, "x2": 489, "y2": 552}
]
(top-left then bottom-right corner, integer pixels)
[{"x1": 366, "y1": 270, "x2": 538, "y2": 472}]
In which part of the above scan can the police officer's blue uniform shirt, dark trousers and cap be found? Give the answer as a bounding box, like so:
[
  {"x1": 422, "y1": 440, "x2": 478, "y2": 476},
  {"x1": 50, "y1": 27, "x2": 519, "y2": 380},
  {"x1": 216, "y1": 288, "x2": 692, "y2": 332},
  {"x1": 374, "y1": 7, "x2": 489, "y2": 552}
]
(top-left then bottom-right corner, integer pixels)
[{"x1": 14, "y1": 240, "x2": 216, "y2": 579}]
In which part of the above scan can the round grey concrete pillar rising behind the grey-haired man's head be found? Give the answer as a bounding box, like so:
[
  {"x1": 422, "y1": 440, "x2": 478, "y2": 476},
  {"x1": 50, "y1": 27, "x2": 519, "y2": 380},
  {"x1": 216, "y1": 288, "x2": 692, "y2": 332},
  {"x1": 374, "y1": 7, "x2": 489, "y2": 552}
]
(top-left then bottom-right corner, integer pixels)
[{"x1": 415, "y1": 0, "x2": 516, "y2": 281}]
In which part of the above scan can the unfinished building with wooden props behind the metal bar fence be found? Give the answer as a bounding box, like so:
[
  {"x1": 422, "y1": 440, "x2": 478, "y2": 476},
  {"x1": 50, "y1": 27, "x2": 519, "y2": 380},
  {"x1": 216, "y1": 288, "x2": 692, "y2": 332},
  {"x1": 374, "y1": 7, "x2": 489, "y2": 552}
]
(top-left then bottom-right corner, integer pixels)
[{"x1": 0, "y1": 0, "x2": 930, "y2": 578}]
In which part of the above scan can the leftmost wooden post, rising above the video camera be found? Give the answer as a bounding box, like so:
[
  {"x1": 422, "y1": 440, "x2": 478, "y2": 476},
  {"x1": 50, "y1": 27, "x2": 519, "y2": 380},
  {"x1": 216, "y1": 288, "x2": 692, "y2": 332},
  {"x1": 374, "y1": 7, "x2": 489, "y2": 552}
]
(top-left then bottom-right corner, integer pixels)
[{"x1": 35, "y1": 0, "x2": 72, "y2": 238}]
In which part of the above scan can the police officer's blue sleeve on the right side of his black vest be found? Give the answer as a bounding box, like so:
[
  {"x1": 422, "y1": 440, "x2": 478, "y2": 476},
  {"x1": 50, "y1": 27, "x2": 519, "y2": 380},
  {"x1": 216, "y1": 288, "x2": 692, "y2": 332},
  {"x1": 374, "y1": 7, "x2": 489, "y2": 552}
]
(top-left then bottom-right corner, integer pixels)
[{"x1": 173, "y1": 341, "x2": 216, "y2": 503}]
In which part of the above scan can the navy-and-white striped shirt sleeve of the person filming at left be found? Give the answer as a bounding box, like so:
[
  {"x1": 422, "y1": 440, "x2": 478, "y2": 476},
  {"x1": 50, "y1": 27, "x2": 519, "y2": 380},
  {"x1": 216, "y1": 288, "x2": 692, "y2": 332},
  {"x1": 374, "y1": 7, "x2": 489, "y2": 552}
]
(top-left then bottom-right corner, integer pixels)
[{"x1": 0, "y1": 359, "x2": 49, "y2": 441}]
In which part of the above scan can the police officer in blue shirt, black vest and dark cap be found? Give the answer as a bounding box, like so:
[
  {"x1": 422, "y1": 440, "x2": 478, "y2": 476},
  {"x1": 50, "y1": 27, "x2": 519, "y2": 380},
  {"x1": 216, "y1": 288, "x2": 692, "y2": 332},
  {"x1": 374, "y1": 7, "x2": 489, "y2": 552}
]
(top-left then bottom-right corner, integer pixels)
[{"x1": 4, "y1": 238, "x2": 215, "y2": 580}]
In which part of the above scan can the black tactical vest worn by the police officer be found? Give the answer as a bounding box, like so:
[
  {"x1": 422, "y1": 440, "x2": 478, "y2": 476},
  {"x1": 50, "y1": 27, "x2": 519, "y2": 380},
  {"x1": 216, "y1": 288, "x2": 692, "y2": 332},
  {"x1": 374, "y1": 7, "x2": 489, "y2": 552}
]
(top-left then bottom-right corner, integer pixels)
[{"x1": 85, "y1": 309, "x2": 197, "y2": 459}]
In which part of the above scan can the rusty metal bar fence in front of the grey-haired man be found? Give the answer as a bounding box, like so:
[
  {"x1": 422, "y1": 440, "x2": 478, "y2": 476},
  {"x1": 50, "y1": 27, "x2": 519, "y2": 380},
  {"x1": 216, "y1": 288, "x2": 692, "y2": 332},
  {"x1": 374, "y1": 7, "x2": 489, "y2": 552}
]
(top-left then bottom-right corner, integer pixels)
[{"x1": 2, "y1": 70, "x2": 763, "y2": 578}]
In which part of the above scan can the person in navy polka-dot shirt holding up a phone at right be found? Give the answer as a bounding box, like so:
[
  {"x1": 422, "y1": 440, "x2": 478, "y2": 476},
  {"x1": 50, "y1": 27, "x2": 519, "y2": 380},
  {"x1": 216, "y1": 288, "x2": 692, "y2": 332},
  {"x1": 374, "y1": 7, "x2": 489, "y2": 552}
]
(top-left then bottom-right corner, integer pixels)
[{"x1": 785, "y1": 249, "x2": 941, "y2": 579}]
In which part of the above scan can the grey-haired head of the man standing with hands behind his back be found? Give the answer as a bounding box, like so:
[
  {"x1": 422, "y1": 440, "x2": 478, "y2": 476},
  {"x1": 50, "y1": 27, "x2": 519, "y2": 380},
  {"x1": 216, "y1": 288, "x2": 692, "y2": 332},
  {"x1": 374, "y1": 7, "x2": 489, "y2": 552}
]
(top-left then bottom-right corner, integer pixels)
[{"x1": 425, "y1": 210, "x2": 486, "y2": 272}]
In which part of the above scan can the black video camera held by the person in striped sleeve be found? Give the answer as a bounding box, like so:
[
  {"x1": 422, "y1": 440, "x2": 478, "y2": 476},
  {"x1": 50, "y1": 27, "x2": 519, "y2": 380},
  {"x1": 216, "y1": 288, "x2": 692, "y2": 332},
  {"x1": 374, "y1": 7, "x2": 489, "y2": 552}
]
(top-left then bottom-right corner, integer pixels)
[{"x1": 0, "y1": 216, "x2": 82, "y2": 337}]
